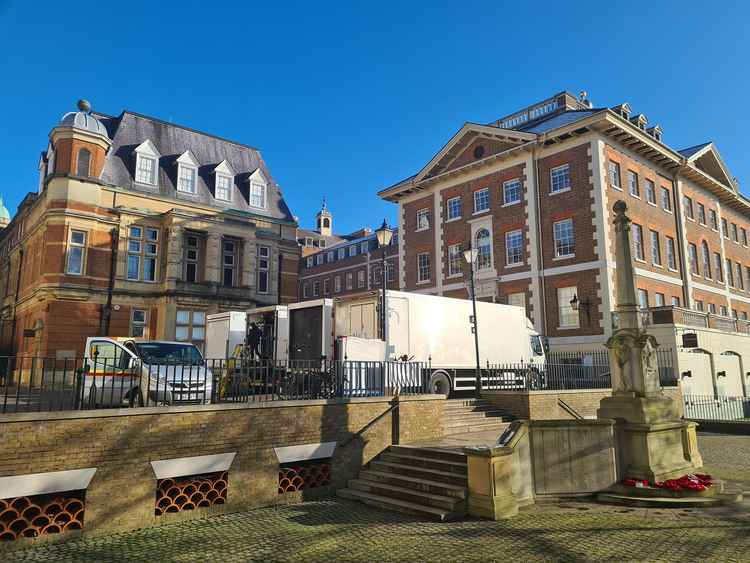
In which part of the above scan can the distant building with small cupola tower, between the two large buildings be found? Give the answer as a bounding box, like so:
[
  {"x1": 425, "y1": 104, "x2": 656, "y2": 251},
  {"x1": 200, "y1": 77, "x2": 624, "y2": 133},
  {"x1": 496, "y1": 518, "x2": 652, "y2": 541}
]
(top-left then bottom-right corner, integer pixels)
[{"x1": 297, "y1": 202, "x2": 398, "y2": 301}]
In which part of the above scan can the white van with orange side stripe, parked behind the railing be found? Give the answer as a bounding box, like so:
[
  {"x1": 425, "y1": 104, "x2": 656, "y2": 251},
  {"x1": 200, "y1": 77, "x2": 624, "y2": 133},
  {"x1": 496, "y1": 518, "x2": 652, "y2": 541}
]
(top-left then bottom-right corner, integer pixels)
[{"x1": 80, "y1": 336, "x2": 213, "y2": 407}]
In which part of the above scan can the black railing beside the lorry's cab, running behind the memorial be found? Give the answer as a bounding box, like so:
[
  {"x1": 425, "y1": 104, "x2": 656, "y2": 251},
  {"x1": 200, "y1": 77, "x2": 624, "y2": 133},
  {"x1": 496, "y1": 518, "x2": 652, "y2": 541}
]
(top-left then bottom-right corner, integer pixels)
[{"x1": 482, "y1": 349, "x2": 677, "y2": 391}]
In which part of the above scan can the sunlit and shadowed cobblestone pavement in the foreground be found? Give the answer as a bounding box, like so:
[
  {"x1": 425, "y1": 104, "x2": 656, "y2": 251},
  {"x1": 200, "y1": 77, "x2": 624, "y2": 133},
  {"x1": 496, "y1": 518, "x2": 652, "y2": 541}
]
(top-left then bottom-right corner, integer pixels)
[{"x1": 5, "y1": 435, "x2": 750, "y2": 563}]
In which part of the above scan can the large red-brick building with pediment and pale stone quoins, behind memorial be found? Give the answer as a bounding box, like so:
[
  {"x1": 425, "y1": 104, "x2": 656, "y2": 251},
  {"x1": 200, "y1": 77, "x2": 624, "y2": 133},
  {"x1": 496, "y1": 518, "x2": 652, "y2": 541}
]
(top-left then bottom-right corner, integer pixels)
[{"x1": 379, "y1": 92, "x2": 750, "y2": 396}]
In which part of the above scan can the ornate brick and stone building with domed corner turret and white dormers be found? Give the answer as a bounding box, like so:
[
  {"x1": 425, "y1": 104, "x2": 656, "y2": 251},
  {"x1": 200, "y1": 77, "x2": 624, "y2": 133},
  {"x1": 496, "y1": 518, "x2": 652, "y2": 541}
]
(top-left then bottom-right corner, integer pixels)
[{"x1": 0, "y1": 101, "x2": 300, "y2": 357}]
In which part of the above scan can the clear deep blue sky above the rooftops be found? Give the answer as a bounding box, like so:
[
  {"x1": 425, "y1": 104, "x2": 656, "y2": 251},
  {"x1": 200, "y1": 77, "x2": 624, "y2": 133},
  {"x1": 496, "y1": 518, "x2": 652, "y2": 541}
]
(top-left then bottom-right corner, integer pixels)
[{"x1": 0, "y1": 0, "x2": 750, "y2": 232}]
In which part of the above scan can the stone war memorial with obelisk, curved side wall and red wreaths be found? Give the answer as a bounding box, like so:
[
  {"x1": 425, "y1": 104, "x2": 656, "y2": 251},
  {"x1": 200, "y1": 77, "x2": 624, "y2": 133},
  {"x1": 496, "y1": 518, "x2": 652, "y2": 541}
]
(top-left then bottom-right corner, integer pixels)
[{"x1": 464, "y1": 201, "x2": 741, "y2": 520}]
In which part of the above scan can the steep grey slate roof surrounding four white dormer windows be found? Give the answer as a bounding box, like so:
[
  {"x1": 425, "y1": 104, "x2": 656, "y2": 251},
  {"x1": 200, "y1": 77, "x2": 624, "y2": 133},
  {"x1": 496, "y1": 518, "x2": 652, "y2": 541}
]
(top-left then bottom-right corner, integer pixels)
[{"x1": 95, "y1": 110, "x2": 295, "y2": 223}]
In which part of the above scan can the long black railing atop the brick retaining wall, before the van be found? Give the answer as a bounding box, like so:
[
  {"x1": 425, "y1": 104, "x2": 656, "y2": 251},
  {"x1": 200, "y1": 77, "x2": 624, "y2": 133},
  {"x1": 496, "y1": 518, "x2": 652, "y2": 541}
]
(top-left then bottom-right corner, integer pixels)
[{"x1": 0, "y1": 357, "x2": 429, "y2": 413}]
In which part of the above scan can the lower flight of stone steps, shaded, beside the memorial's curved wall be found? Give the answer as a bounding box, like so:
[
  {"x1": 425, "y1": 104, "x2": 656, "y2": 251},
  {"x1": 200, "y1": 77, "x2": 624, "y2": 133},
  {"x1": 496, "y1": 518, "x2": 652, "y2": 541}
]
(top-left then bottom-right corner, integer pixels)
[{"x1": 337, "y1": 446, "x2": 468, "y2": 521}]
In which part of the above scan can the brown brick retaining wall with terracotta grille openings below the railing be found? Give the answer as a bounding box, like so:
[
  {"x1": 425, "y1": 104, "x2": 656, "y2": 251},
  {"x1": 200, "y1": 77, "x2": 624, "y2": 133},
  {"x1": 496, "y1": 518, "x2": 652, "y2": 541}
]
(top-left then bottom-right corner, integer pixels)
[{"x1": 0, "y1": 395, "x2": 444, "y2": 544}]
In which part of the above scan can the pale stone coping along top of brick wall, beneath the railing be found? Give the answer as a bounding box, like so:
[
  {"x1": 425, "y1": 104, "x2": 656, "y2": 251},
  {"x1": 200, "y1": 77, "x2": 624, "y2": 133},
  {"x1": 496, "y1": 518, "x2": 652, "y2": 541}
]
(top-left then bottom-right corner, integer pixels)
[{"x1": 0, "y1": 394, "x2": 447, "y2": 423}]
